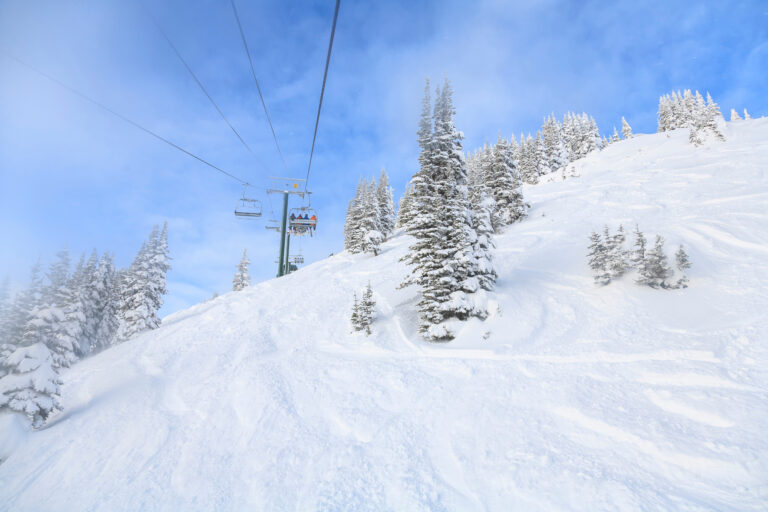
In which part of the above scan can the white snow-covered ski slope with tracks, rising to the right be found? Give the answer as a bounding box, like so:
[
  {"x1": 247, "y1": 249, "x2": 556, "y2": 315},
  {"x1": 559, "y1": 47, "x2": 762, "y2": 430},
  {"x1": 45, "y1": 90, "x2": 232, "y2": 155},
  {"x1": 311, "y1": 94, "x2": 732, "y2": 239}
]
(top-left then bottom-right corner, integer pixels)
[{"x1": 0, "y1": 119, "x2": 768, "y2": 511}]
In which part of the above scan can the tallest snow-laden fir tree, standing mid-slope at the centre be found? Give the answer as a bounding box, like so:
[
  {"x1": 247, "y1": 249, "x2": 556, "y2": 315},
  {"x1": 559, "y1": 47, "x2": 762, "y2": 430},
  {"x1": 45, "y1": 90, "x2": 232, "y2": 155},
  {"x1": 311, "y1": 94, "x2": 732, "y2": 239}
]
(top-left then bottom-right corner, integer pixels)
[{"x1": 405, "y1": 80, "x2": 486, "y2": 341}]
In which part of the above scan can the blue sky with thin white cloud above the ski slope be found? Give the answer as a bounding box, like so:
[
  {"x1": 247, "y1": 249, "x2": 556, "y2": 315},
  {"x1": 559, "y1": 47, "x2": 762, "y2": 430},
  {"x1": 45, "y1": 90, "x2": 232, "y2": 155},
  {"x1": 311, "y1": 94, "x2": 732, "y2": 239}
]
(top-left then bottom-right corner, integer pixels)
[{"x1": 0, "y1": 0, "x2": 768, "y2": 313}]
